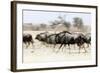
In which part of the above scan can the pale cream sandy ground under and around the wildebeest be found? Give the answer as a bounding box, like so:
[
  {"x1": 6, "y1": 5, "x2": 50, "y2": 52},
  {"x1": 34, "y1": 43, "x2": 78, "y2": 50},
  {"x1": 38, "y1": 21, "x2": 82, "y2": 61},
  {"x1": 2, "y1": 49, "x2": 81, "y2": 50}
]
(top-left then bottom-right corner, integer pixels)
[{"x1": 23, "y1": 31, "x2": 91, "y2": 63}]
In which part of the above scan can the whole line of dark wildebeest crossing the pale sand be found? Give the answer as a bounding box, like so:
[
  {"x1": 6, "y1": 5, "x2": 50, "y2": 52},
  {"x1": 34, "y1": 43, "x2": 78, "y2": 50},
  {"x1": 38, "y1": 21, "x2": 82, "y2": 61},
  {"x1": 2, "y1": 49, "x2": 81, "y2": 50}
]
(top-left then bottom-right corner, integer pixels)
[{"x1": 23, "y1": 31, "x2": 91, "y2": 53}]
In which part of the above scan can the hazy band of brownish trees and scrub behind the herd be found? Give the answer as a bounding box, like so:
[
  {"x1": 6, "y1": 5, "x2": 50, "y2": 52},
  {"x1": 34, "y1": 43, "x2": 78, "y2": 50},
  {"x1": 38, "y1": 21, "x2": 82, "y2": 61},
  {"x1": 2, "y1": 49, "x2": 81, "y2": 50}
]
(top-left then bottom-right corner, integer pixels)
[{"x1": 23, "y1": 15, "x2": 91, "y2": 32}]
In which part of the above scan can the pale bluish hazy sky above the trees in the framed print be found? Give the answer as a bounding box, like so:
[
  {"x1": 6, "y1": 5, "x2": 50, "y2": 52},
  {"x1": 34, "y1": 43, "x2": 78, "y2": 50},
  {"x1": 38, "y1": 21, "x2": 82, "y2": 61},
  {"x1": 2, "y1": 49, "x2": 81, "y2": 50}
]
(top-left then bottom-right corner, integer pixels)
[{"x1": 23, "y1": 10, "x2": 91, "y2": 25}]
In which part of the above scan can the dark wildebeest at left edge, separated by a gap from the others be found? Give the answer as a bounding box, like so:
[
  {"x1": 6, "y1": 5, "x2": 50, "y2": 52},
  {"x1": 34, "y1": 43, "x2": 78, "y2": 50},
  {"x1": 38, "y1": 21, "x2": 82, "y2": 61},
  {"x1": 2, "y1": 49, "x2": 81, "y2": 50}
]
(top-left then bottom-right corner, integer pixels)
[{"x1": 23, "y1": 34, "x2": 34, "y2": 48}]
